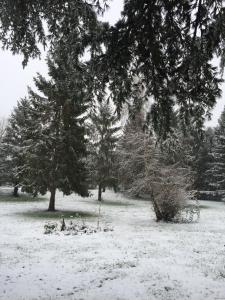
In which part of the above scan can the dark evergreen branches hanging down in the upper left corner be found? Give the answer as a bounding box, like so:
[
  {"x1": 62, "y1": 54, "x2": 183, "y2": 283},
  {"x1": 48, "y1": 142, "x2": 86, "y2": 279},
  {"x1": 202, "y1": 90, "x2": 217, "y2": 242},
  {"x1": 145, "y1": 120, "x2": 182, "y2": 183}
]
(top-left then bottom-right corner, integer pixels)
[{"x1": 0, "y1": 0, "x2": 106, "y2": 65}]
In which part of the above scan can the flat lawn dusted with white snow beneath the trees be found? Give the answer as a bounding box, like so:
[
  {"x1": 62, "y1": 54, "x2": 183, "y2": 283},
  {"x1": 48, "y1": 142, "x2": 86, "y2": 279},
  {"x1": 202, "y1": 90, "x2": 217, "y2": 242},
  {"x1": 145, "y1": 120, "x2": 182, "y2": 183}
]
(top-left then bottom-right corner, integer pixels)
[{"x1": 0, "y1": 191, "x2": 225, "y2": 300}]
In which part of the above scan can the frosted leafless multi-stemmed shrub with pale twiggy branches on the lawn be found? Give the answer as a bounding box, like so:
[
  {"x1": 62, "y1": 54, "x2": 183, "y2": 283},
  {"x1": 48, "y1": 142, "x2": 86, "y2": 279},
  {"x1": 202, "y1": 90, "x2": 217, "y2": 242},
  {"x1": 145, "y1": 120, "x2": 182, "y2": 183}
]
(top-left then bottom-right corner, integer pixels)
[{"x1": 118, "y1": 115, "x2": 198, "y2": 221}]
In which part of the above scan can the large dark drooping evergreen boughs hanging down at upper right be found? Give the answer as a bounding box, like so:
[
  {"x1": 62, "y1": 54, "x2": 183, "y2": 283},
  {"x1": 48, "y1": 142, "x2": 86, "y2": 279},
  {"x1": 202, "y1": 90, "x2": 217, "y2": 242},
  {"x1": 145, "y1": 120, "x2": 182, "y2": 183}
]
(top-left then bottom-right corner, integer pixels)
[{"x1": 99, "y1": 0, "x2": 225, "y2": 138}]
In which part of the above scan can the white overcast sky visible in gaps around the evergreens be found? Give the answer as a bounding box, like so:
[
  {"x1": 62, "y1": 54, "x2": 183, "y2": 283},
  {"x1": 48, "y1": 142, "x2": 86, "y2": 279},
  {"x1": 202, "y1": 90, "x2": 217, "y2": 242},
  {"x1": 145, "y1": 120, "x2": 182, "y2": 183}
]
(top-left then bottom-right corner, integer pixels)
[{"x1": 0, "y1": 0, "x2": 225, "y2": 126}]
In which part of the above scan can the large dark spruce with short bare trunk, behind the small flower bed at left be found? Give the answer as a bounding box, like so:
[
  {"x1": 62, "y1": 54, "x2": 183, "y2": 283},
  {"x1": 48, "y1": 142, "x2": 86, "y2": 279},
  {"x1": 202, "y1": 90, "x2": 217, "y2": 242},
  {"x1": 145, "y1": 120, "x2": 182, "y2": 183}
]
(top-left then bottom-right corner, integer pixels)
[{"x1": 4, "y1": 54, "x2": 88, "y2": 211}]
